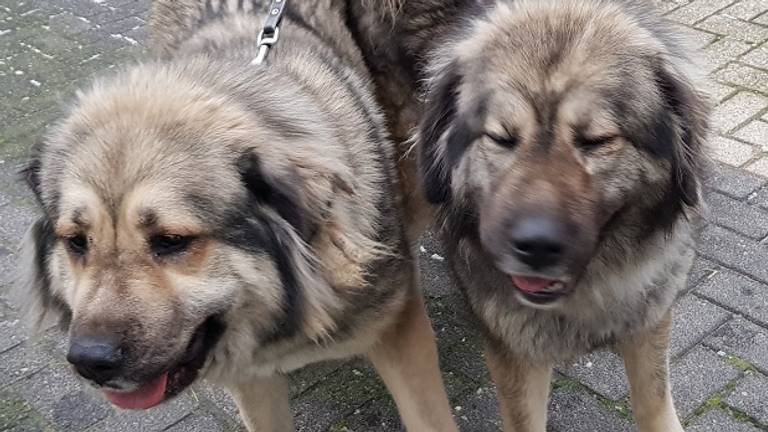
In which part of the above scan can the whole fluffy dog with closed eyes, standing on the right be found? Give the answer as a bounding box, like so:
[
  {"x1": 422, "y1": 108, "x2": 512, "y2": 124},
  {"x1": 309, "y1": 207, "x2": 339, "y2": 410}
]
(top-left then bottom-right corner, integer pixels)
[{"x1": 353, "y1": 0, "x2": 709, "y2": 432}]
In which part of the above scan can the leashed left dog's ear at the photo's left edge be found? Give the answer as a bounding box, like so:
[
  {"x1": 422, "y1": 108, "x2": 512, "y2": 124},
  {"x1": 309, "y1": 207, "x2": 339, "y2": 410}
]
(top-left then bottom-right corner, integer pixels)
[{"x1": 13, "y1": 216, "x2": 72, "y2": 329}]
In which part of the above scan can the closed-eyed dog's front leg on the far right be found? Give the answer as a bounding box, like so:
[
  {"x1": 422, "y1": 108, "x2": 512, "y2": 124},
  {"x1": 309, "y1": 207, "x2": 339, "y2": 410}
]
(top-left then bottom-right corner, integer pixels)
[{"x1": 618, "y1": 312, "x2": 683, "y2": 432}]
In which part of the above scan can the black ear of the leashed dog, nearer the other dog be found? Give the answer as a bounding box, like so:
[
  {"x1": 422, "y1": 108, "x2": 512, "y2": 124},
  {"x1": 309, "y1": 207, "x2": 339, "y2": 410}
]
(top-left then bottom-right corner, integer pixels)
[{"x1": 237, "y1": 152, "x2": 314, "y2": 241}]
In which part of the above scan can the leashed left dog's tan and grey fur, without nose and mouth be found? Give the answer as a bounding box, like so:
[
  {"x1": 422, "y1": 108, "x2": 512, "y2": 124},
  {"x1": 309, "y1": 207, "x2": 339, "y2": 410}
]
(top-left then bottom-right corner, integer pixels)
[{"x1": 13, "y1": 0, "x2": 455, "y2": 431}]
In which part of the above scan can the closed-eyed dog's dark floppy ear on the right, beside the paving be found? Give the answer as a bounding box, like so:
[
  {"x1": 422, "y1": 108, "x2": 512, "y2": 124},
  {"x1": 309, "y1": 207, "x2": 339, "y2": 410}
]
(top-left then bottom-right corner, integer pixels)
[{"x1": 656, "y1": 61, "x2": 710, "y2": 213}]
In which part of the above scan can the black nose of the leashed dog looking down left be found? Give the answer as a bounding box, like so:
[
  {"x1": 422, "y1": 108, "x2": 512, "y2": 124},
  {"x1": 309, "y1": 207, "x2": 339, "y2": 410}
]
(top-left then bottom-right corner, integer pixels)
[{"x1": 67, "y1": 337, "x2": 124, "y2": 384}]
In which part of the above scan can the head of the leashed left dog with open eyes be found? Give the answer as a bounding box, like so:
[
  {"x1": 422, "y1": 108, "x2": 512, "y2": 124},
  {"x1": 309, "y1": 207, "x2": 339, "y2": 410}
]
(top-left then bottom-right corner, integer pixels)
[{"x1": 13, "y1": 66, "x2": 340, "y2": 408}]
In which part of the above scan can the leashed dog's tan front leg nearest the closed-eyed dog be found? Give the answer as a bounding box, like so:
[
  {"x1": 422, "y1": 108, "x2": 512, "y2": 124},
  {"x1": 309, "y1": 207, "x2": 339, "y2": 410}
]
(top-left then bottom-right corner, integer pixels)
[{"x1": 368, "y1": 290, "x2": 457, "y2": 432}]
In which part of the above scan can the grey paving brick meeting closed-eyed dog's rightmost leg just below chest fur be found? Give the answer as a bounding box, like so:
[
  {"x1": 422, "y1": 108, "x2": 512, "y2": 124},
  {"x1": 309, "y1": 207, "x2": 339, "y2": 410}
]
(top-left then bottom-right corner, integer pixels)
[{"x1": 669, "y1": 295, "x2": 731, "y2": 358}]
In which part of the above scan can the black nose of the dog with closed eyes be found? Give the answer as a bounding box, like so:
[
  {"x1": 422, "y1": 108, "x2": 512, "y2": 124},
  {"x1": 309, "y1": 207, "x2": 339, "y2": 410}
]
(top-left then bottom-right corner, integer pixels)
[{"x1": 510, "y1": 216, "x2": 565, "y2": 270}]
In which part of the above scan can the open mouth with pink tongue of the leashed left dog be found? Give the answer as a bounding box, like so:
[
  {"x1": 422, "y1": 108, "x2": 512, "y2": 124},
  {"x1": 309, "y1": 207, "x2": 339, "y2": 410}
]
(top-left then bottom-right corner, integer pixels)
[{"x1": 104, "y1": 317, "x2": 224, "y2": 410}]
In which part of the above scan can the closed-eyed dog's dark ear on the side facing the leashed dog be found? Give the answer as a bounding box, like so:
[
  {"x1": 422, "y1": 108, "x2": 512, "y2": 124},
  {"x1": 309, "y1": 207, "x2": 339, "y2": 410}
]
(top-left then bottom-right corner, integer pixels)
[{"x1": 416, "y1": 62, "x2": 469, "y2": 203}]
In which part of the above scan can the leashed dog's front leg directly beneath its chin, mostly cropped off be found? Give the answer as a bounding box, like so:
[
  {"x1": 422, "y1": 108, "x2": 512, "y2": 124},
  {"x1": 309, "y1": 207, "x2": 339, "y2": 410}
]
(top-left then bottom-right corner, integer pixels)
[{"x1": 228, "y1": 374, "x2": 293, "y2": 432}]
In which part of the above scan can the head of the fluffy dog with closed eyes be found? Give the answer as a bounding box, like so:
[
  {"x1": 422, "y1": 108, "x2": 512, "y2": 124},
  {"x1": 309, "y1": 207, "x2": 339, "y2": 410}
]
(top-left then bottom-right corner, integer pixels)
[{"x1": 416, "y1": 0, "x2": 708, "y2": 307}]
